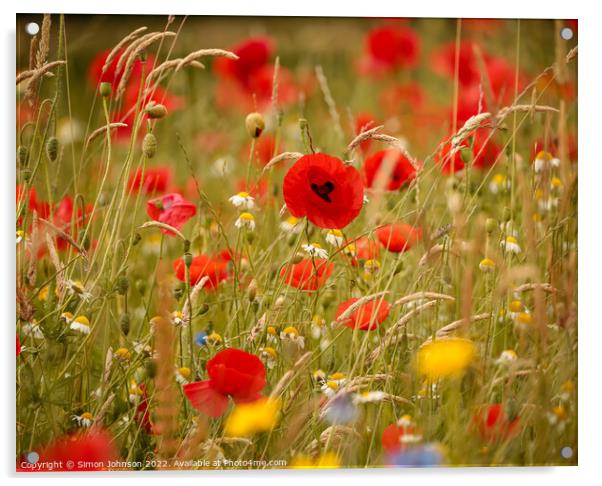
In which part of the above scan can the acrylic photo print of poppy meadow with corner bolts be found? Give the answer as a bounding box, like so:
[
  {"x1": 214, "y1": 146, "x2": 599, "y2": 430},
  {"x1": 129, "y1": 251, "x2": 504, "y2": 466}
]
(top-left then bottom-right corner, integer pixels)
[{"x1": 15, "y1": 14, "x2": 578, "y2": 472}]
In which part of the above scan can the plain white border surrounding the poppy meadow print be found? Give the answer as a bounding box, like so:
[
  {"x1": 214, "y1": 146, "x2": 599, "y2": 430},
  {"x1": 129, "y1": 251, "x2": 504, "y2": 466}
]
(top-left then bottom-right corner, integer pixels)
[{"x1": 0, "y1": 0, "x2": 602, "y2": 486}]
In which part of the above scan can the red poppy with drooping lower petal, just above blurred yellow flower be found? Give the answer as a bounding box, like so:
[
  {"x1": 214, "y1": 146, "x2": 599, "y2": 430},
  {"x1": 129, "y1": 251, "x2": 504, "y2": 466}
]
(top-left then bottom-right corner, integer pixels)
[{"x1": 183, "y1": 348, "x2": 266, "y2": 417}]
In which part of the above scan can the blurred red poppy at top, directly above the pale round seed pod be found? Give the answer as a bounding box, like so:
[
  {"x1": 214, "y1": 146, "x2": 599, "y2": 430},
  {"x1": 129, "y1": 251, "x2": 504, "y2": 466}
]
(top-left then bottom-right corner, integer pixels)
[{"x1": 213, "y1": 37, "x2": 273, "y2": 86}]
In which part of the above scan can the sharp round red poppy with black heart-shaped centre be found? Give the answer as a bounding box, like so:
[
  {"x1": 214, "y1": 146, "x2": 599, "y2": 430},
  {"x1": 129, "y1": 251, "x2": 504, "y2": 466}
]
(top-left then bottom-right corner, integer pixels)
[{"x1": 283, "y1": 153, "x2": 364, "y2": 229}]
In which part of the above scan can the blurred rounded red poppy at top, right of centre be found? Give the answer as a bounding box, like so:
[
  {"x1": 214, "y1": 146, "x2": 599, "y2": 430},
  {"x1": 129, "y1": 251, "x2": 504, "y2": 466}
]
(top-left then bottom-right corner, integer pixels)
[{"x1": 359, "y1": 24, "x2": 420, "y2": 75}]
